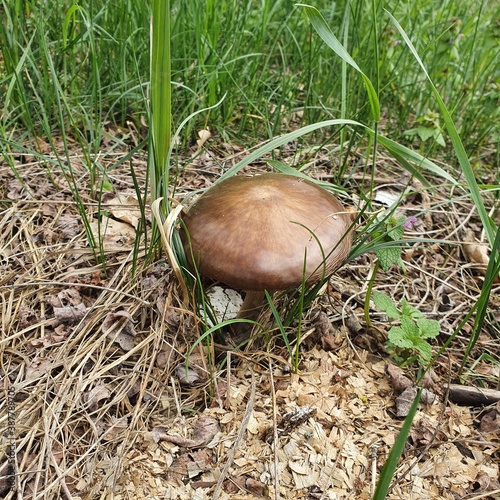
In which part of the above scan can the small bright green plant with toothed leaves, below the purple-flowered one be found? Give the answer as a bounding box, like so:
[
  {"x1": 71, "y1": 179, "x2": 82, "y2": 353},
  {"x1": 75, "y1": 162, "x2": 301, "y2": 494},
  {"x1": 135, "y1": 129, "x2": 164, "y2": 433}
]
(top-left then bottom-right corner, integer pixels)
[{"x1": 373, "y1": 291, "x2": 440, "y2": 365}]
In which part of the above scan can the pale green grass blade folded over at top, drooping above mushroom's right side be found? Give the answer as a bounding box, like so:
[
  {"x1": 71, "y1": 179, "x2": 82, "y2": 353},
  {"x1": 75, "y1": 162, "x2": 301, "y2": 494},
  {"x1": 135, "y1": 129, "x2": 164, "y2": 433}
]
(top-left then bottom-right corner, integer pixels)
[{"x1": 297, "y1": 3, "x2": 380, "y2": 122}]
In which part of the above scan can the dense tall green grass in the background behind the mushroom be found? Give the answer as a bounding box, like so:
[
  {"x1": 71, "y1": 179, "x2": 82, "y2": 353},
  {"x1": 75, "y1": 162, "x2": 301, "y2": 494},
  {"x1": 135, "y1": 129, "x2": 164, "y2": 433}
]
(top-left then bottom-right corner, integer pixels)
[{"x1": 0, "y1": 0, "x2": 500, "y2": 158}]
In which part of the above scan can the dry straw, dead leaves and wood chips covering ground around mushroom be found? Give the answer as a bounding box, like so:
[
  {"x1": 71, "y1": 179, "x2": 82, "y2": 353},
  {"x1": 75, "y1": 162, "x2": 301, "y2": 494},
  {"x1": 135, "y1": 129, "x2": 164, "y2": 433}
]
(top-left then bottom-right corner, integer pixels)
[{"x1": 0, "y1": 136, "x2": 500, "y2": 500}]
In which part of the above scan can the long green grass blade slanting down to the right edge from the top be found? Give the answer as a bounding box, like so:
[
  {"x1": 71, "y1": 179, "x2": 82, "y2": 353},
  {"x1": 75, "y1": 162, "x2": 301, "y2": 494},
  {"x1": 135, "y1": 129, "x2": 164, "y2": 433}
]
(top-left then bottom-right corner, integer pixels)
[{"x1": 385, "y1": 10, "x2": 496, "y2": 250}]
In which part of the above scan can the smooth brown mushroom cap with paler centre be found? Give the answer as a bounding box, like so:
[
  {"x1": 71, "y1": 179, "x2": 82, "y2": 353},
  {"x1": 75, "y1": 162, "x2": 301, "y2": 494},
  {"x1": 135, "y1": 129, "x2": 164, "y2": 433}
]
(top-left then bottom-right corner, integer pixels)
[{"x1": 181, "y1": 174, "x2": 352, "y2": 291}]
